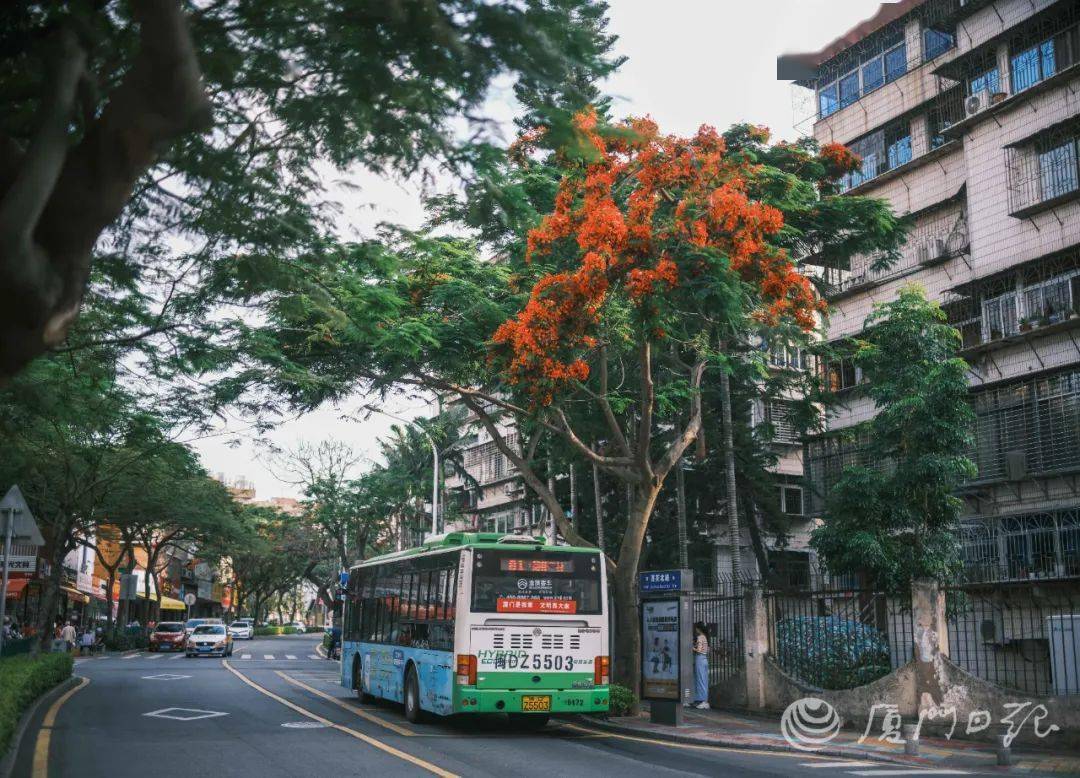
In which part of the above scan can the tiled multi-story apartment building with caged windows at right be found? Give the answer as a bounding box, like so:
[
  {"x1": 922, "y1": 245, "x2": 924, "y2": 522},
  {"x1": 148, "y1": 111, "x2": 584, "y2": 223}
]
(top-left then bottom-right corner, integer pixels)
[{"x1": 778, "y1": 0, "x2": 1080, "y2": 578}]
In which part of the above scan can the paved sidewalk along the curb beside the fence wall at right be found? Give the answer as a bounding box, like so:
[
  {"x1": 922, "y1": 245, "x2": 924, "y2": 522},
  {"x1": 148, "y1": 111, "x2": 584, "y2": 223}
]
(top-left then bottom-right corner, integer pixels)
[{"x1": 589, "y1": 703, "x2": 1080, "y2": 775}]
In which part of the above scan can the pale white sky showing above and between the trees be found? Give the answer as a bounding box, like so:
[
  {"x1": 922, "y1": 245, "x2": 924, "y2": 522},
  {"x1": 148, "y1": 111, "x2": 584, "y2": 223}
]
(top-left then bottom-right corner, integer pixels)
[{"x1": 194, "y1": 0, "x2": 879, "y2": 499}]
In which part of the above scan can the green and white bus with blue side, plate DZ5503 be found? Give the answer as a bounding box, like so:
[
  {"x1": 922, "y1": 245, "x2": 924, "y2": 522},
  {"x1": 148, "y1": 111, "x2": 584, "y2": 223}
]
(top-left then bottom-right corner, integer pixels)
[{"x1": 341, "y1": 533, "x2": 610, "y2": 726}]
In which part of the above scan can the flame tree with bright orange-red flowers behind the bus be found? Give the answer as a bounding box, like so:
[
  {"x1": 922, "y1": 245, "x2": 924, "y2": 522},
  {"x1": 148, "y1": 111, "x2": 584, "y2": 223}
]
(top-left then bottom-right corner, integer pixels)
[{"x1": 238, "y1": 111, "x2": 903, "y2": 700}]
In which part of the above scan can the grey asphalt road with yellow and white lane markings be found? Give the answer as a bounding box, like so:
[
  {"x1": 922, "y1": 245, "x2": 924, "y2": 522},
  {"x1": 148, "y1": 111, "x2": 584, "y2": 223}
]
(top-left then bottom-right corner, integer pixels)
[{"x1": 14, "y1": 635, "x2": 1019, "y2": 778}]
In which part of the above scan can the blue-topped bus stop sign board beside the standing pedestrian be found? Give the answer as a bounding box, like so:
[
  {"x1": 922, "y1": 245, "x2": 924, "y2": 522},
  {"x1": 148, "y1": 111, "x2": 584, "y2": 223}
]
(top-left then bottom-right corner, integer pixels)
[{"x1": 637, "y1": 569, "x2": 693, "y2": 726}]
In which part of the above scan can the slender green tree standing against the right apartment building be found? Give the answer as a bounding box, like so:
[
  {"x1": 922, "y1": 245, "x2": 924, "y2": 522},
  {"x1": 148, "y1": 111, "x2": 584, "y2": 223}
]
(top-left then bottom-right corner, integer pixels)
[{"x1": 811, "y1": 286, "x2": 975, "y2": 590}]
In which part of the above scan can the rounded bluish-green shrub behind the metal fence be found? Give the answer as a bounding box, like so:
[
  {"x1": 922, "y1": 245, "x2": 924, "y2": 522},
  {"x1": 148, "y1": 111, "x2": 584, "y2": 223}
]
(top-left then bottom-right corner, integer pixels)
[{"x1": 777, "y1": 616, "x2": 890, "y2": 689}]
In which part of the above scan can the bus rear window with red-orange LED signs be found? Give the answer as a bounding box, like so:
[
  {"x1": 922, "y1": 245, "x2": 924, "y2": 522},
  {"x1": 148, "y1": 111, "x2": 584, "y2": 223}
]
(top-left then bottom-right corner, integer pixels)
[{"x1": 472, "y1": 549, "x2": 602, "y2": 615}]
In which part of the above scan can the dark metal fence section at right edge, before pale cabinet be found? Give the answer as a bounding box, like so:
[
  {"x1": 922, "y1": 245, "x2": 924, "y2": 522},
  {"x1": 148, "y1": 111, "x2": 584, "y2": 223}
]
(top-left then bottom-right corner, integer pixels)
[{"x1": 945, "y1": 568, "x2": 1080, "y2": 695}]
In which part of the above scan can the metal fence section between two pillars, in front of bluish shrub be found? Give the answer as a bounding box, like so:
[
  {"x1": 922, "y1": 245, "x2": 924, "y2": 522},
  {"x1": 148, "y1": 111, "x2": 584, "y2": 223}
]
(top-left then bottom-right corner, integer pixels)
[{"x1": 765, "y1": 576, "x2": 913, "y2": 689}]
